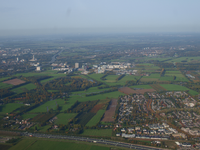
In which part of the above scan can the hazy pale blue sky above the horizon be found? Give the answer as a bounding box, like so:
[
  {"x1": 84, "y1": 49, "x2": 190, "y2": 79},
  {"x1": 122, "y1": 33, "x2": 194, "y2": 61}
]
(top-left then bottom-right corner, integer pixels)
[{"x1": 0, "y1": 0, "x2": 200, "y2": 35}]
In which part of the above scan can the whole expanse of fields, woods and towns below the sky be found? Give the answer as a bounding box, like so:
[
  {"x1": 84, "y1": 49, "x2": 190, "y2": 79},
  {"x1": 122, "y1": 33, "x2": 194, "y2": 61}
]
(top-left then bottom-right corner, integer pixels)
[{"x1": 0, "y1": 34, "x2": 200, "y2": 150}]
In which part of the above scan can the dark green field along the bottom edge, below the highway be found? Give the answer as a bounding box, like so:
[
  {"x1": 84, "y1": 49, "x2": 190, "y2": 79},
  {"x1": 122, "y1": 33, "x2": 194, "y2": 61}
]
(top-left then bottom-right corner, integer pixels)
[{"x1": 9, "y1": 139, "x2": 110, "y2": 150}]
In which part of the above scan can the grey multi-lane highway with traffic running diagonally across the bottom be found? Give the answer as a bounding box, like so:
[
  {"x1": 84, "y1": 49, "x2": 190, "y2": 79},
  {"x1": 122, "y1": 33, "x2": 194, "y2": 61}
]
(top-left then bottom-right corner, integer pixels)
[{"x1": 21, "y1": 132, "x2": 166, "y2": 150}]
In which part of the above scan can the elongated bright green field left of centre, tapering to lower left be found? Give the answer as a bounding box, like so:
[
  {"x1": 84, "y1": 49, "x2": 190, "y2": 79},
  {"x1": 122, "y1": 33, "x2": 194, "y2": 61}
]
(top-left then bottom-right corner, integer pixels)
[{"x1": 29, "y1": 99, "x2": 65, "y2": 113}]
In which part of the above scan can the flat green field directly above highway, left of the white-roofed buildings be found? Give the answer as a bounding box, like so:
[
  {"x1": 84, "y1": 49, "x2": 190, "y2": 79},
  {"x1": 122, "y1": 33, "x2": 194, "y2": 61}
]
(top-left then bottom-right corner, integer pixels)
[{"x1": 82, "y1": 129, "x2": 112, "y2": 137}]
